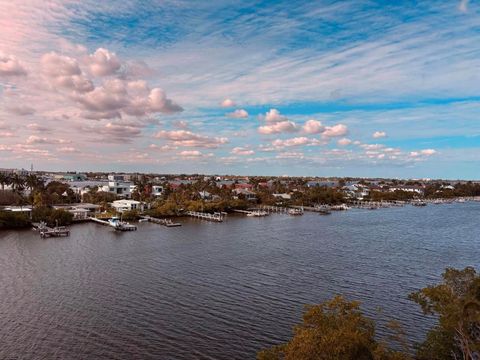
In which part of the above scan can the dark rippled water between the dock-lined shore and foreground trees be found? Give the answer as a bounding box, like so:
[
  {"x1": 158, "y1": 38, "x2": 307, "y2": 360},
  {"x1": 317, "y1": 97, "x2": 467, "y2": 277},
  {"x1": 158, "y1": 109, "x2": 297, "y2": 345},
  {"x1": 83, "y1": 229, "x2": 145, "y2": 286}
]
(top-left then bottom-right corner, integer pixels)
[{"x1": 0, "y1": 203, "x2": 480, "y2": 359}]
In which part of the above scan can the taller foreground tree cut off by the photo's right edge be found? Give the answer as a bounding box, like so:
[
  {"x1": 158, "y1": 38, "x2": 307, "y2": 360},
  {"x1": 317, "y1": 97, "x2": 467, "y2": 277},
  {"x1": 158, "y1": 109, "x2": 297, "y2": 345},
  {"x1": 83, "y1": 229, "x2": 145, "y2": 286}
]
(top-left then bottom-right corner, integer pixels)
[{"x1": 409, "y1": 267, "x2": 480, "y2": 360}]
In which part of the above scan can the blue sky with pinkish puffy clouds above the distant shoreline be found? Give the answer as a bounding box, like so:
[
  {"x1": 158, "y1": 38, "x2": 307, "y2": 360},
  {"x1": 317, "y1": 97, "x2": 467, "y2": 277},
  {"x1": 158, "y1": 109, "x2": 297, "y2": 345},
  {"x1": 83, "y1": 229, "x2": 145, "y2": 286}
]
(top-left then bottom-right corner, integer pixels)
[{"x1": 0, "y1": 0, "x2": 480, "y2": 179}]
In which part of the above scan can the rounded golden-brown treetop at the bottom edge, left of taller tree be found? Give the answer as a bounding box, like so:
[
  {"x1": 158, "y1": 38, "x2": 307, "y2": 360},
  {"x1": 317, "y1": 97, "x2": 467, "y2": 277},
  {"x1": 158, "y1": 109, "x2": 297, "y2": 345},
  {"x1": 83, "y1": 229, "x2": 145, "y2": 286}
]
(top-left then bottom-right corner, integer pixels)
[{"x1": 257, "y1": 296, "x2": 410, "y2": 360}]
